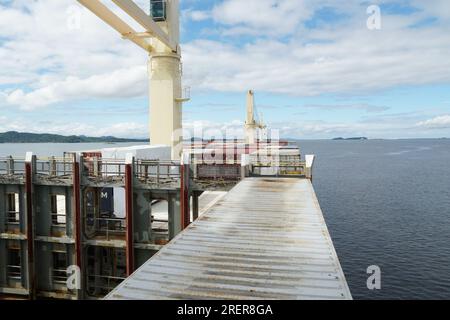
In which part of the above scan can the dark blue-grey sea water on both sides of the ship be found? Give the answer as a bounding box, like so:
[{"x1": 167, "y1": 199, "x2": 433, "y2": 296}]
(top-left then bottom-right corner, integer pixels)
[{"x1": 0, "y1": 140, "x2": 450, "y2": 299}]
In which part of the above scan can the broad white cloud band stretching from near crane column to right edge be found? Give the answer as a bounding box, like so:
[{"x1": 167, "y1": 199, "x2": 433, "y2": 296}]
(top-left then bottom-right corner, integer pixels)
[{"x1": 184, "y1": 20, "x2": 450, "y2": 96}]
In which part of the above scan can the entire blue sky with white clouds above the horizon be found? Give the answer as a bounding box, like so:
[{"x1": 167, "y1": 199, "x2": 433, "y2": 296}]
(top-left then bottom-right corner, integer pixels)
[{"x1": 0, "y1": 0, "x2": 450, "y2": 139}]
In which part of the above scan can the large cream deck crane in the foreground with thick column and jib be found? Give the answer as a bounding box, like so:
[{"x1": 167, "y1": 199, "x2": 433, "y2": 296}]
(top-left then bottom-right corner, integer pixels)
[{"x1": 77, "y1": 0, "x2": 189, "y2": 160}]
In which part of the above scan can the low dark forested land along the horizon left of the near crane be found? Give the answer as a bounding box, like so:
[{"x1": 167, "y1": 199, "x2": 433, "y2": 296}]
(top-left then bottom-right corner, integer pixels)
[{"x1": 0, "y1": 131, "x2": 149, "y2": 143}]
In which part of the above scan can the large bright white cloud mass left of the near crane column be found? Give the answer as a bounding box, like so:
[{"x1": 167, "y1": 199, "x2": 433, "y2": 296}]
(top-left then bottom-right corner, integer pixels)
[{"x1": 0, "y1": 0, "x2": 147, "y2": 109}]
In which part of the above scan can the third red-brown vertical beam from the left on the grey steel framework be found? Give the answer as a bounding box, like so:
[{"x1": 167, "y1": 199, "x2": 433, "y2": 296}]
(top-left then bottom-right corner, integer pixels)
[{"x1": 125, "y1": 161, "x2": 134, "y2": 276}]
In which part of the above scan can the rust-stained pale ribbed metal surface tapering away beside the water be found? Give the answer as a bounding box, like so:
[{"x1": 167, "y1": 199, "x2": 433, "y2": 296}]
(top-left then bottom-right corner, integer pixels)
[{"x1": 106, "y1": 178, "x2": 352, "y2": 300}]
